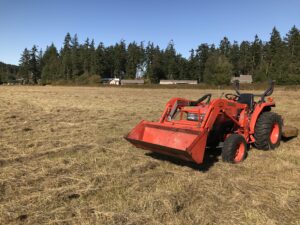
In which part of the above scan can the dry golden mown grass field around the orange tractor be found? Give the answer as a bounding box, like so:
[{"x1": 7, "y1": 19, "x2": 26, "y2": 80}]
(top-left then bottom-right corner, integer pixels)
[{"x1": 0, "y1": 86, "x2": 300, "y2": 225}]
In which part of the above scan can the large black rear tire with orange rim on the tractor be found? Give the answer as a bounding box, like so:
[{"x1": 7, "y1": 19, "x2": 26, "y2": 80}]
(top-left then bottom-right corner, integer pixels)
[{"x1": 254, "y1": 112, "x2": 282, "y2": 150}]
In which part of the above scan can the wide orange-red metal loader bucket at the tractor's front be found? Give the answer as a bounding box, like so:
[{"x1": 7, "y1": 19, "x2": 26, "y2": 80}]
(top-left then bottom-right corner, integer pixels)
[{"x1": 125, "y1": 121, "x2": 207, "y2": 163}]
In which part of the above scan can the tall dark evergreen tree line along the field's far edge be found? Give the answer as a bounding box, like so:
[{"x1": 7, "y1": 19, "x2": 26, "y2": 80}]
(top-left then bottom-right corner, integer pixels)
[{"x1": 11, "y1": 26, "x2": 300, "y2": 84}]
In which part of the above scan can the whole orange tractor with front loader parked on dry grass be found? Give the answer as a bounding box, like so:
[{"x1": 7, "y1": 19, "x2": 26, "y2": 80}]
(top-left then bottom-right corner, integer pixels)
[{"x1": 125, "y1": 81, "x2": 298, "y2": 164}]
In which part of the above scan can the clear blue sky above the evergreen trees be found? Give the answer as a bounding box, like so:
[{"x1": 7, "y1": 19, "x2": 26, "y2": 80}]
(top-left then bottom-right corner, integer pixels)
[{"x1": 0, "y1": 0, "x2": 300, "y2": 64}]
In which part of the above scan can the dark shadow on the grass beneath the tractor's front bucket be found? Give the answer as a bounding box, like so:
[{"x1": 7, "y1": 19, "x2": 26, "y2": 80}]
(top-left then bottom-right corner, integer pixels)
[{"x1": 146, "y1": 148, "x2": 222, "y2": 172}]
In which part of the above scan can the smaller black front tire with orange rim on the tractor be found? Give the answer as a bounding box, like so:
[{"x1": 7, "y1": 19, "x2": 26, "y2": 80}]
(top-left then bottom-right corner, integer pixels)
[{"x1": 222, "y1": 134, "x2": 248, "y2": 163}]
